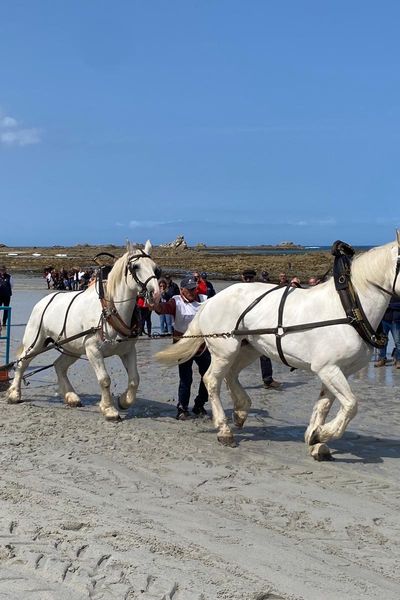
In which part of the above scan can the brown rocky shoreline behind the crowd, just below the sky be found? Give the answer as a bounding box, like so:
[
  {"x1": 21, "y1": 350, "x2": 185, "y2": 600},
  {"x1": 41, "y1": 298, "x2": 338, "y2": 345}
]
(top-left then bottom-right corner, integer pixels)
[{"x1": 0, "y1": 245, "x2": 340, "y2": 281}]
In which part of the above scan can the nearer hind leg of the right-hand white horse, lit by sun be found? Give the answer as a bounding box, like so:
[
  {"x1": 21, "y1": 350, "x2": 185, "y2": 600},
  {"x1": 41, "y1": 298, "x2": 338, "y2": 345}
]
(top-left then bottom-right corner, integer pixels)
[{"x1": 203, "y1": 356, "x2": 235, "y2": 446}]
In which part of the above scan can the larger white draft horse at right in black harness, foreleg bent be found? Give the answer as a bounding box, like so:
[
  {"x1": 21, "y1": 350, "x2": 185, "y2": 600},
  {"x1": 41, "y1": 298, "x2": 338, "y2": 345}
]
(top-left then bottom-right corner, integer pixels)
[{"x1": 156, "y1": 237, "x2": 400, "y2": 460}]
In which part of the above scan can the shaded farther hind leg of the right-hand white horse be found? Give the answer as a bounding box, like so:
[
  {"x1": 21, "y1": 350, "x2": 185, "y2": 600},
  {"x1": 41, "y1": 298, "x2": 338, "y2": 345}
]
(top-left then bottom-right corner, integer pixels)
[{"x1": 225, "y1": 345, "x2": 260, "y2": 428}]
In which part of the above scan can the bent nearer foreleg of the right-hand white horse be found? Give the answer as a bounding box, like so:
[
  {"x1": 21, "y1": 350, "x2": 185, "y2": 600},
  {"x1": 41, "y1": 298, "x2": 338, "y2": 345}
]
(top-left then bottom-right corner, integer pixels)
[{"x1": 307, "y1": 366, "x2": 357, "y2": 454}]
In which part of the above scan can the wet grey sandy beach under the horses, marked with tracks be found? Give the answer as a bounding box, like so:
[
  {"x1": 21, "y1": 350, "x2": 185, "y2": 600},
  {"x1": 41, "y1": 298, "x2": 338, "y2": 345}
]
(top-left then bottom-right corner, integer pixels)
[{"x1": 0, "y1": 277, "x2": 400, "y2": 600}]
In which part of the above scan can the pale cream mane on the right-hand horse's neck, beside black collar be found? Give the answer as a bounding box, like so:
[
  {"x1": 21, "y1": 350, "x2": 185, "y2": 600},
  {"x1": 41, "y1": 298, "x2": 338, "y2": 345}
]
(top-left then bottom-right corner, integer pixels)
[{"x1": 351, "y1": 242, "x2": 393, "y2": 292}]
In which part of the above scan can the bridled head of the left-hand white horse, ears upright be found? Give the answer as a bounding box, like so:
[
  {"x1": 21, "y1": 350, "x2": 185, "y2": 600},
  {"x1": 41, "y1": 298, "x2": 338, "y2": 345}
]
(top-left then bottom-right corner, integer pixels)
[{"x1": 125, "y1": 240, "x2": 161, "y2": 300}]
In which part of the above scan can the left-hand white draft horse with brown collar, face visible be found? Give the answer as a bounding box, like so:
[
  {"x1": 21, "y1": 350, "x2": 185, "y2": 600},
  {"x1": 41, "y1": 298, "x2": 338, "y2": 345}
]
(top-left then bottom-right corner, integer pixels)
[{"x1": 7, "y1": 241, "x2": 158, "y2": 420}]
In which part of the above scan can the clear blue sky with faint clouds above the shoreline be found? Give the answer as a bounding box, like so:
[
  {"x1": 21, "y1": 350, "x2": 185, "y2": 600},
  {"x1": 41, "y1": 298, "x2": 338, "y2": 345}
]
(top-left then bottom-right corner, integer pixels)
[{"x1": 0, "y1": 0, "x2": 400, "y2": 246}]
